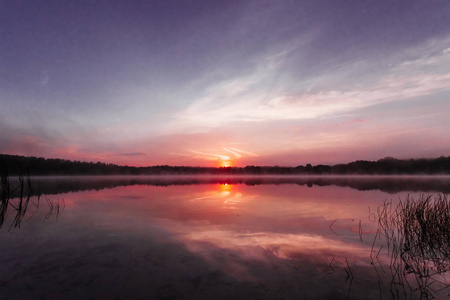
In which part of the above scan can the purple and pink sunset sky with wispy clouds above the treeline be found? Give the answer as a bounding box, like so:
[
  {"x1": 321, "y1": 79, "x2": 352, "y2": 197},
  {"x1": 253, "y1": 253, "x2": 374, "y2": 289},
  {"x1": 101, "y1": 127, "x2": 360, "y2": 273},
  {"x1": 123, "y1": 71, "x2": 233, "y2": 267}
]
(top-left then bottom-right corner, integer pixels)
[{"x1": 0, "y1": 0, "x2": 450, "y2": 166}]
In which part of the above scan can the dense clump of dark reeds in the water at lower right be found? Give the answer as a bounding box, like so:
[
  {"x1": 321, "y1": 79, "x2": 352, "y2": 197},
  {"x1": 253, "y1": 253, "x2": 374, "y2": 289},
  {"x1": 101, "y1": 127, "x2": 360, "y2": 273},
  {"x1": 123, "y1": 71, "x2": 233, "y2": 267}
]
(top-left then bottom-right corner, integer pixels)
[{"x1": 372, "y1": 195, "x2": 450, "y2": 299}]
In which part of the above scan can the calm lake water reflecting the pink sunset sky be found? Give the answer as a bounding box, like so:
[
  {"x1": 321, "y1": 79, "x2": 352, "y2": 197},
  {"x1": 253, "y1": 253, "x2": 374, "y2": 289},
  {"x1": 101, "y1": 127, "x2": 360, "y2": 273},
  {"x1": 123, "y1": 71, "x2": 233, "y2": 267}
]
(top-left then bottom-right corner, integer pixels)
[{"x1": 0, "y1": 177, "x2": 450, "y2": 299}]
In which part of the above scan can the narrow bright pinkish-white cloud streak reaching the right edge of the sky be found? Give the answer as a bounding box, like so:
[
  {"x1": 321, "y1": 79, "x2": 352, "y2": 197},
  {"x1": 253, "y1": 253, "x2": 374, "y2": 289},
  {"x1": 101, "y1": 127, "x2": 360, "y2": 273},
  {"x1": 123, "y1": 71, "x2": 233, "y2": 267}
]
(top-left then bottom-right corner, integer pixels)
[{"x1": 181, "y1": 74, "x2": 450, "y2": 126}]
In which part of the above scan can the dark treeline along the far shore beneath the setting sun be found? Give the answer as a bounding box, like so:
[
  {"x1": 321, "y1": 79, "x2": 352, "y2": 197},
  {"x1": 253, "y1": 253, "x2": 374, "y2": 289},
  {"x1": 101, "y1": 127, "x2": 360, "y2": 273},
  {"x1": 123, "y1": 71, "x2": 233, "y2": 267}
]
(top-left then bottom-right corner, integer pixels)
[{"x1": 0, "y1": 154, "x2": 450, "y2": 176}]
